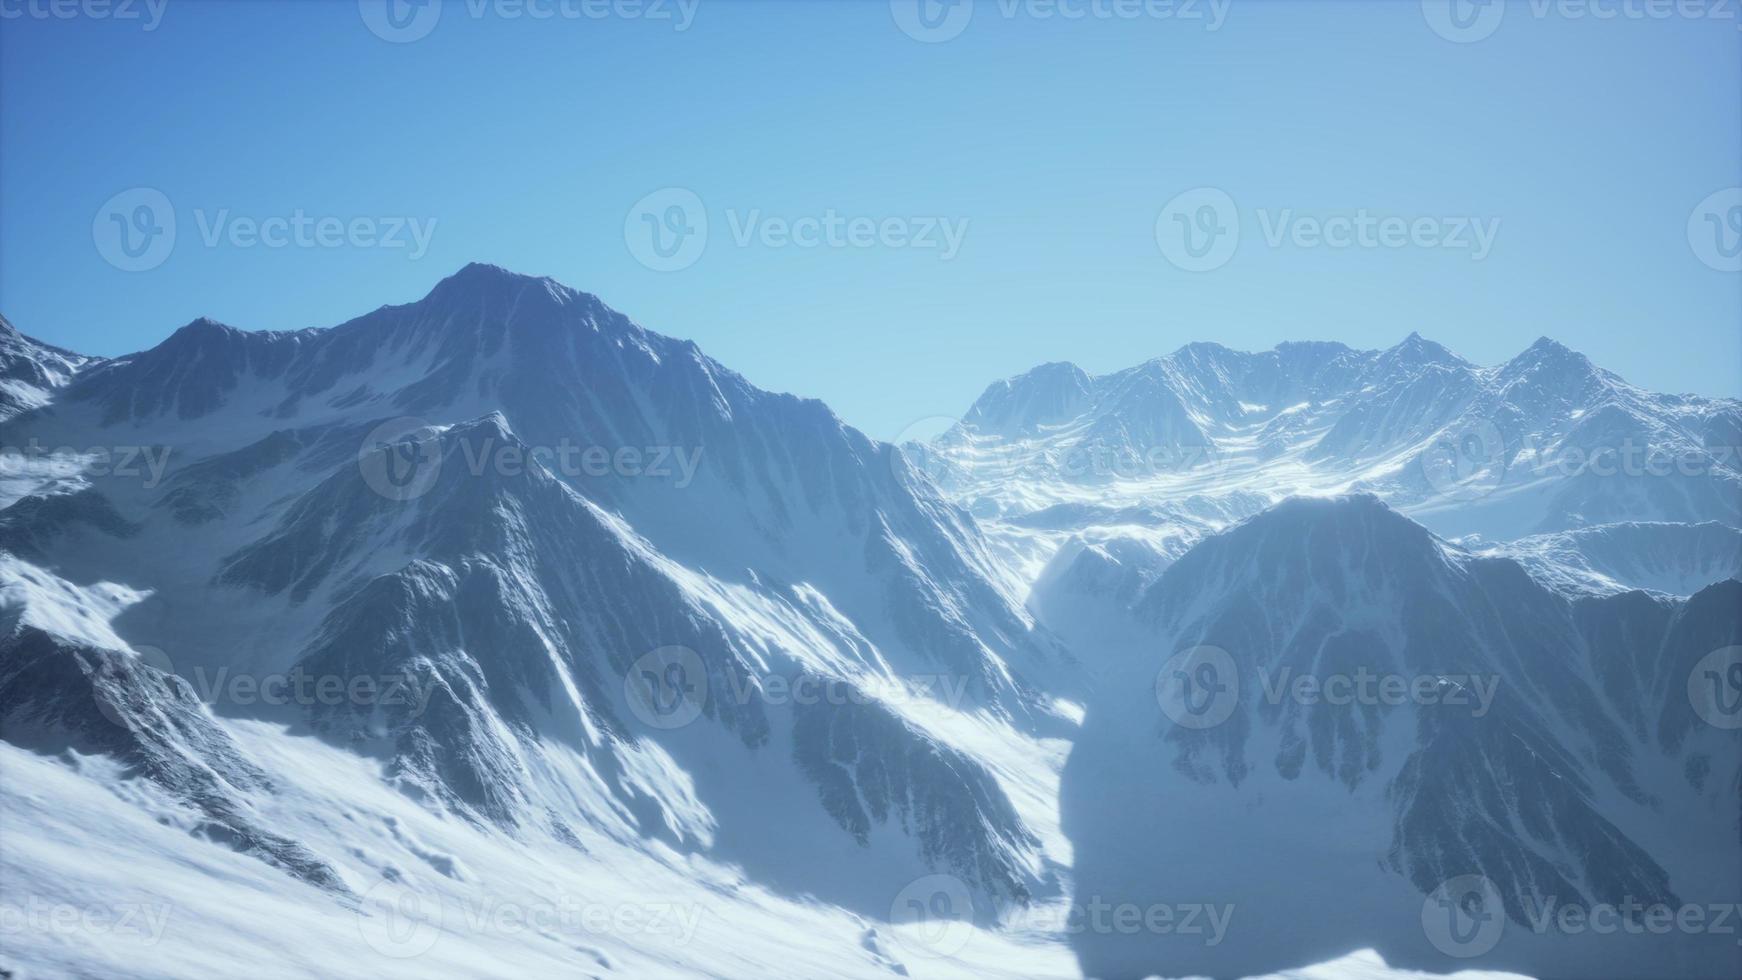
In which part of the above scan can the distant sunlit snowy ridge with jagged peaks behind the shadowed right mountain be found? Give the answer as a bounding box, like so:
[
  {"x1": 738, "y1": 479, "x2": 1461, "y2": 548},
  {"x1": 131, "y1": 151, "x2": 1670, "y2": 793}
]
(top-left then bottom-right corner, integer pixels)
[{"x1": 911, "y1": 334, "x2": 1742, "y2": 580}]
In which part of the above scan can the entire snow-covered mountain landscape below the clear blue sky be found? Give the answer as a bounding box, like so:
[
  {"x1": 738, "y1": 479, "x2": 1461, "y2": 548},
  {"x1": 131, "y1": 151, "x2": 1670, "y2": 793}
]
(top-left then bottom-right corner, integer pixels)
[{"x1": 0, "y1": 265, "x2": 1742, "y2": 977}]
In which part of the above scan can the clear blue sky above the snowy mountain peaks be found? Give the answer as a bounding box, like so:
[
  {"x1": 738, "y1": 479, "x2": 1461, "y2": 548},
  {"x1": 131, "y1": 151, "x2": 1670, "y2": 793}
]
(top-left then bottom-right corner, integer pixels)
[{"x1": 0, "y1": 0, "x2": 1742, "y2": 437}]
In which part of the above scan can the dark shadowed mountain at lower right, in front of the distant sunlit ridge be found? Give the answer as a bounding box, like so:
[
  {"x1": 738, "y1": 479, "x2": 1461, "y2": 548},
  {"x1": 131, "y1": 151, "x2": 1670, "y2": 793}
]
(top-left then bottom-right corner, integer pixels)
[{"x1": 1063, "y1": 494, "x2": 1742, "y2": 978}]
